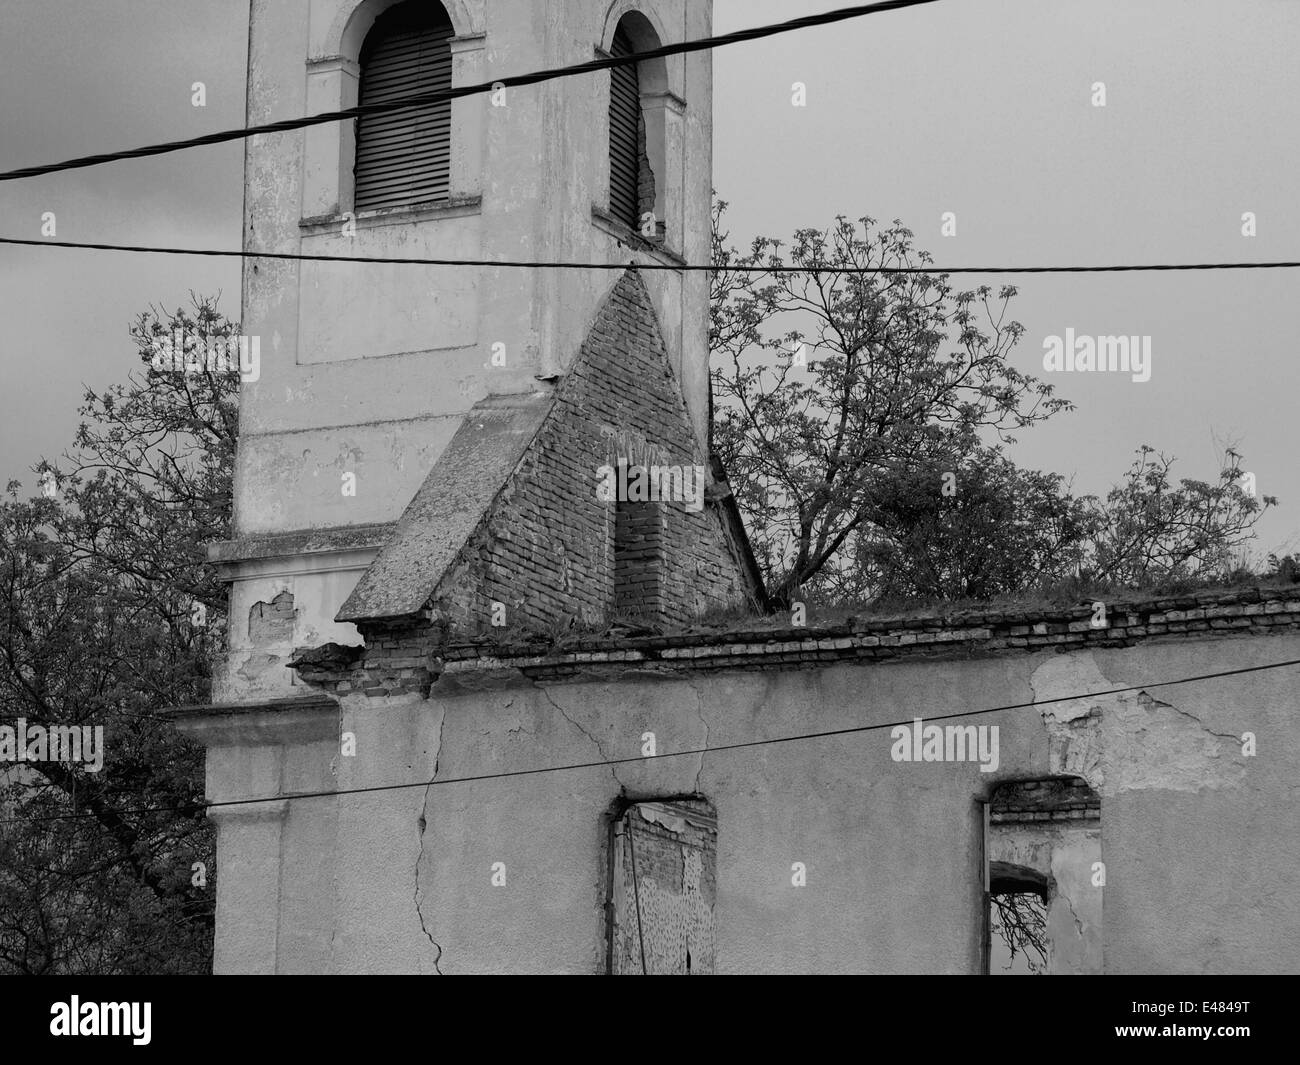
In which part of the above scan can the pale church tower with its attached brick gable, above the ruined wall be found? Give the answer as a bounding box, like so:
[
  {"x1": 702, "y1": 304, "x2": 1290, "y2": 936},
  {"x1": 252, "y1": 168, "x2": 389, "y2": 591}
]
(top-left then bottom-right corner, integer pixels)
[{"x1": 212, "y1": 0, "x2": 753, "y2": 703}]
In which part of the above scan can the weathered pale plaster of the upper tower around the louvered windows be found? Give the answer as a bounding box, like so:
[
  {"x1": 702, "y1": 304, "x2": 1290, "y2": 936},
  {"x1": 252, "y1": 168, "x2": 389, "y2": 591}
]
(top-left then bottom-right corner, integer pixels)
[{"x1": 235, "y1": 0, "x2": 711, "y2": 536}]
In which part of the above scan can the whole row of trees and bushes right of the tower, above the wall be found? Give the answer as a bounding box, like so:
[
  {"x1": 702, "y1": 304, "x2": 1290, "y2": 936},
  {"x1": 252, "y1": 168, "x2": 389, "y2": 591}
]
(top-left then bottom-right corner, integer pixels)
[{"x1": 710, "y1": 200, "x2": 1277, "y2": 605}]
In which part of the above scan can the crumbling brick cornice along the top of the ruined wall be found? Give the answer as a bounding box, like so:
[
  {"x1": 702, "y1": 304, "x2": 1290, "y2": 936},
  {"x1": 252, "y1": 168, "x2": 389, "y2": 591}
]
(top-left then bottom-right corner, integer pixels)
[{"x1": 443, "y1": 585, "x2": 1300, "y2": 680}]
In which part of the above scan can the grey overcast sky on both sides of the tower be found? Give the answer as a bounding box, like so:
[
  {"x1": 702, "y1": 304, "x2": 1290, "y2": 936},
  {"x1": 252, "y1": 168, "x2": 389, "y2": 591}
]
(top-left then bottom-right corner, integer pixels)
[{"x1": 0, "y1": 0, "x2": 1300, "y2": 554}]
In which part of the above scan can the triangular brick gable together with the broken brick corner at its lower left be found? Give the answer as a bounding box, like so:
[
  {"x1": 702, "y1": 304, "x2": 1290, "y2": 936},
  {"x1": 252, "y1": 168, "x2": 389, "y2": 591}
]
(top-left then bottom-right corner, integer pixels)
[{"x1": 302, "y1": 270, "x2": 750, "y2": 697}]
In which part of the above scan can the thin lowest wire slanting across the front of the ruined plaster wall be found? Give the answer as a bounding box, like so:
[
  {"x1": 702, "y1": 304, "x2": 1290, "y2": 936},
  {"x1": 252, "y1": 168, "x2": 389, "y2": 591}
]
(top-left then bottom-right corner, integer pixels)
[{"x1": 0, "y1": 658, "x2": 1300, "y2": 824}]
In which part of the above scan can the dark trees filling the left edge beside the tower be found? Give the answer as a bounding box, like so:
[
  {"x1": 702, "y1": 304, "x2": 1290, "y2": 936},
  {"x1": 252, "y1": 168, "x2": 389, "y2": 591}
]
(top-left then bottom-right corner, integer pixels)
[{"x1": 0, "y1": 299, "x2": 239, "y2": 974}]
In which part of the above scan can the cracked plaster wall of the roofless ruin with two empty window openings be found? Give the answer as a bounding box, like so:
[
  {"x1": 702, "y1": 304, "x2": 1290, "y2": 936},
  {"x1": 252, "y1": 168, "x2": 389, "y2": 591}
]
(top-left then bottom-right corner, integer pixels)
[{"x1": 180, "y1": 621, "x2": 1300, "y2": 973}]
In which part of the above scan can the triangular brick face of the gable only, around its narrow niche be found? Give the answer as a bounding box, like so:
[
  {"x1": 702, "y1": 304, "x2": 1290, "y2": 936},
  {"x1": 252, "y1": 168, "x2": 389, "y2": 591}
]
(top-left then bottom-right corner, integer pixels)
[{"x1": 430, "y1": 270, "x2": 746, "y2": 633}]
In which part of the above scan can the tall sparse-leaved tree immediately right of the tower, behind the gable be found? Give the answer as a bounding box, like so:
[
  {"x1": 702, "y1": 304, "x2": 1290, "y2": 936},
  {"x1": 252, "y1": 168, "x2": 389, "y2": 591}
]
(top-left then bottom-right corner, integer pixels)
[{"x1": 711, "y1": 203, "x2": 1070, "y2": 602}]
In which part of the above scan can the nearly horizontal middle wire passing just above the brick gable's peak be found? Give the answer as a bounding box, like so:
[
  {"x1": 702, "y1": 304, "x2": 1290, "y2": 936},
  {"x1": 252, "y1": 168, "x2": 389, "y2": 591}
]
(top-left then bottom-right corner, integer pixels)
[{"x1": 0, "y1": 237, "x2": 1300, "y2": 274}]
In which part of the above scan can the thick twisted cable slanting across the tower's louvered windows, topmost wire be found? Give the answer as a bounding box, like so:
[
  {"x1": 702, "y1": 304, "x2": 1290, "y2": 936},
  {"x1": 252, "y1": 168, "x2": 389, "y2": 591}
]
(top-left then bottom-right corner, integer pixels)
[{"x1": 0, "y1": 0, "x2": 937, "y2": 181}]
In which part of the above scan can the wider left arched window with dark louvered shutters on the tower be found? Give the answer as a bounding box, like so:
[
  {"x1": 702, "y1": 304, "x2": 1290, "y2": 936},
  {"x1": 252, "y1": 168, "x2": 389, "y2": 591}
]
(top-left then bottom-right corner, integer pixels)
[{"x1": 354, "y1": 0, "x2": 454, "y2": 211}]
